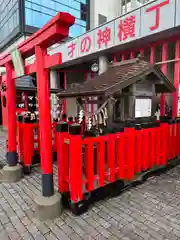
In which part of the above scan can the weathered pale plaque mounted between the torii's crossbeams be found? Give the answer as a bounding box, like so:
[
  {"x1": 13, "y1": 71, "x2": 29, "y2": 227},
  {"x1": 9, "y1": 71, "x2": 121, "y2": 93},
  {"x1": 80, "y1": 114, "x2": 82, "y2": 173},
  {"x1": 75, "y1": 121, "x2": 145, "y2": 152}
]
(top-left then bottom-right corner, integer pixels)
[{"x1": 11, "y1": 48, "x2": 24, "y2": 77}]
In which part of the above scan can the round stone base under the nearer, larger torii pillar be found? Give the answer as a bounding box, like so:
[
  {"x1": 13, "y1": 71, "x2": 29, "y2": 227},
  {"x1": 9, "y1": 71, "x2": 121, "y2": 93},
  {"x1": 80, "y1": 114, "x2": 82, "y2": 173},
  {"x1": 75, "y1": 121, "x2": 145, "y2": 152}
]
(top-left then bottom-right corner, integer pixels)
[{"x1": 34, "y1": 193, "x2": 62, "y2": 221}]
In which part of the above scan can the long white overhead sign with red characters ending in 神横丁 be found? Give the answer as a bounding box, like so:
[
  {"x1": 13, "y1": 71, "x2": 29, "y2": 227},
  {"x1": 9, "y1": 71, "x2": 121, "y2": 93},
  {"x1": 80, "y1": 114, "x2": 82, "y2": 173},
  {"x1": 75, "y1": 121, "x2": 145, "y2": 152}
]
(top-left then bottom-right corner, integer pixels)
[{"x1": 58, "y1": 0, "x2": 180, "y2": 62}]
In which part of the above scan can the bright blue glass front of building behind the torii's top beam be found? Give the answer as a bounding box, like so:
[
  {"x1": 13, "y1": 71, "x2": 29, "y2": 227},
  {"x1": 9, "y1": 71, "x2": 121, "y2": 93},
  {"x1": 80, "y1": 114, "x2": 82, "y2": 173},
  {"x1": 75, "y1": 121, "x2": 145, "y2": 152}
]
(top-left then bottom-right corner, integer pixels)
[{"x1": 25, "y1": 0, "x2": 87, "y2": 37}]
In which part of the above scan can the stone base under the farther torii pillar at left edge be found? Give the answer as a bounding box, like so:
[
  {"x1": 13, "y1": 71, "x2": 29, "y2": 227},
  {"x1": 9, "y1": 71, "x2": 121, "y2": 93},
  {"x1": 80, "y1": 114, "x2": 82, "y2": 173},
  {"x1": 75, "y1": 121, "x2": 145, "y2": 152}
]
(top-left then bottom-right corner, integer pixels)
[{"x1": 1, "y1": 164, "x2": 23, "y2": 183}]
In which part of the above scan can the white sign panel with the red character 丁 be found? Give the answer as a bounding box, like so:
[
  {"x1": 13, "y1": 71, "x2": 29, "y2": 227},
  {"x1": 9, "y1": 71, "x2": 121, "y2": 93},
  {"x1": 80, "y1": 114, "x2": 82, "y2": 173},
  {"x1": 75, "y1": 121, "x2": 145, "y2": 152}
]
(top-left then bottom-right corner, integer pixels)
[{"x1": 141, "y1": 0, "x2": 175, "y2": 37}]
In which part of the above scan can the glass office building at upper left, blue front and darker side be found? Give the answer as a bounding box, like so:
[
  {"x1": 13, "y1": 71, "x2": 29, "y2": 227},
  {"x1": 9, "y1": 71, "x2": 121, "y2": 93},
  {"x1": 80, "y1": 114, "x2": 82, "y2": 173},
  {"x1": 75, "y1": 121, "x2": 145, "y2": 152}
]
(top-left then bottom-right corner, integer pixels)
[{"x1": 0, "y1": 0, "x2": 89, "y2": 52}]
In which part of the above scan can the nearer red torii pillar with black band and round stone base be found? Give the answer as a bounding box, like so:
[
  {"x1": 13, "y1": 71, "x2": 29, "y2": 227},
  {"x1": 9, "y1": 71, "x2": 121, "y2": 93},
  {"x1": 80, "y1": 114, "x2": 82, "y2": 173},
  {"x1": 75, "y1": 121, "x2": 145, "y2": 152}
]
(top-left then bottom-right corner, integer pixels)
[{"x1": 35, "y1": 46, "x2": 61, "y2": 220}]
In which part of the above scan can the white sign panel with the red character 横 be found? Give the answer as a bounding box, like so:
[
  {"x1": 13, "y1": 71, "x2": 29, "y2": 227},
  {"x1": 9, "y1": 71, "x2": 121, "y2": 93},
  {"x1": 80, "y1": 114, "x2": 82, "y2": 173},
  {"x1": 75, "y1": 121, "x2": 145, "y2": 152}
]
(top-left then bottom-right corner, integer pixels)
[{"x1": 115, "y1": 9, "x2": 141, "y2": 45}]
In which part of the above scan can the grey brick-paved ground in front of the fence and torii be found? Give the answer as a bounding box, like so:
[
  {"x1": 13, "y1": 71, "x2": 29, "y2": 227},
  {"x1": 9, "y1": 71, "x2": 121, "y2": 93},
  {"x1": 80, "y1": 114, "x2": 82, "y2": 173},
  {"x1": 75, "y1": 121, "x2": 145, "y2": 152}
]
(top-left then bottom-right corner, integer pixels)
[{"x1": 0, "y1": 132, "x2": 180, "y2": 240}]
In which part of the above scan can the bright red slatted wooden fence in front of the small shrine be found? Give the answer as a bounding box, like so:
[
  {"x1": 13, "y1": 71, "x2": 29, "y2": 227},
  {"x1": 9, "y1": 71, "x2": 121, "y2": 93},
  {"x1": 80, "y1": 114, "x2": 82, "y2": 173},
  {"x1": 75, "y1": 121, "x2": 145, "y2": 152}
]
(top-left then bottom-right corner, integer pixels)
[{"x1": 57, "y1": 123, "x2": 180, "y2": 203}]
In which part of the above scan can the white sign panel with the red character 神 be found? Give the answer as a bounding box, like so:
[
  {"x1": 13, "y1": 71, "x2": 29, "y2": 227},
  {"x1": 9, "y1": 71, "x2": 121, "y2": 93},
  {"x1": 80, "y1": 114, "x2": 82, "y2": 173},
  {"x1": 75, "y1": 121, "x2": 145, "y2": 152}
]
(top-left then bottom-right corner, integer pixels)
[{"x1": 94, "y1": 21, "x2": 114, "y2": 52}]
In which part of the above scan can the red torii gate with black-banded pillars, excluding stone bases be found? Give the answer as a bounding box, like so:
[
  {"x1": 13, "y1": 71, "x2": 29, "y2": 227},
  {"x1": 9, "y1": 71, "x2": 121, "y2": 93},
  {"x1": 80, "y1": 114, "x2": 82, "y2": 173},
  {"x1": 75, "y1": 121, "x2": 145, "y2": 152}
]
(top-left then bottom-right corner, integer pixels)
[{"x1": 0, "y1": 12, "x2": 75, "y2": 197}]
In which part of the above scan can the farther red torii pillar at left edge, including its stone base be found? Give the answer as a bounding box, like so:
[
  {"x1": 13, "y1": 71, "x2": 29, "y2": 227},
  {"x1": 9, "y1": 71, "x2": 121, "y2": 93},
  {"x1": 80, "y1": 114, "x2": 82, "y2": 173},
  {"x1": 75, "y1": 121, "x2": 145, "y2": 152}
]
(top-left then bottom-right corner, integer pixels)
[{"x1": 2, "y1": 62, "x2": 22, "y2": 182}]
